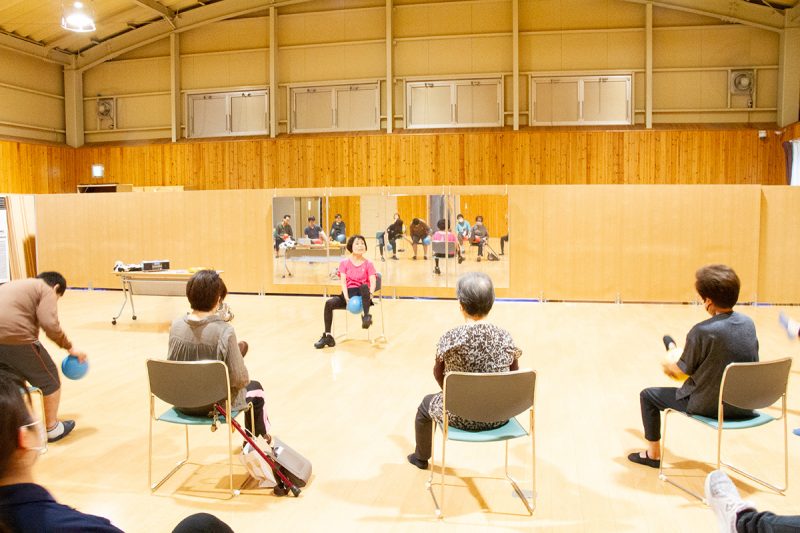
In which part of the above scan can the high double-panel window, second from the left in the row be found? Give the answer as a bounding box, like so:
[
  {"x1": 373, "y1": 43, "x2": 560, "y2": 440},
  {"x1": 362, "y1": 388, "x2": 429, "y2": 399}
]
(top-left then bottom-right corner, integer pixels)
[{"x1": 289, "y1": 82, "x2": 380, "y2": 133}]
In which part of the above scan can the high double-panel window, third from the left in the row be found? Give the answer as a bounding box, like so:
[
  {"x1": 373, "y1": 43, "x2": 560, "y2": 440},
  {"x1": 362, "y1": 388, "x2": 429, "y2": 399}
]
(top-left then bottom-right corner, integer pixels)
[{"x1": 406, "y1": 78, "x2": 503, "y2": 129}]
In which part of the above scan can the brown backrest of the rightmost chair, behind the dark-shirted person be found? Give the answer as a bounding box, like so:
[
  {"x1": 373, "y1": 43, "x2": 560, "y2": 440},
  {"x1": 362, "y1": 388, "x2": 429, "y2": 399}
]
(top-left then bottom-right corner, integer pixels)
[{"x1": 720, "y1": 357, "x2": 792, "y2": 409}]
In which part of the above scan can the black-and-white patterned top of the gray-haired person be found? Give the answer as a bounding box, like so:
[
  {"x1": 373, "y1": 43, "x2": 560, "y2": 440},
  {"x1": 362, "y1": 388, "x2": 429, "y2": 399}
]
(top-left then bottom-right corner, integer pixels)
[{"x1": 429, "y1": 321, "x2": 522, "y2": 431}]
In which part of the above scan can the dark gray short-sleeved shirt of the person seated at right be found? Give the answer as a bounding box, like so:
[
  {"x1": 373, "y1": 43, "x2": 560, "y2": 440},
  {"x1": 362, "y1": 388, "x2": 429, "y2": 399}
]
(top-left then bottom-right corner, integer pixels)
[{"x1": 676, "y1": 311, "x2": 758, "y2": 418}]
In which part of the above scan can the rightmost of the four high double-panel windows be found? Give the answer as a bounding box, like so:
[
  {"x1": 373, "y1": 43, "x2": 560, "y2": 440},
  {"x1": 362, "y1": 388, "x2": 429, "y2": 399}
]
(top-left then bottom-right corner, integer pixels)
[{"x1": 530, "y1": 75, "x2": 633, "y2": 126}]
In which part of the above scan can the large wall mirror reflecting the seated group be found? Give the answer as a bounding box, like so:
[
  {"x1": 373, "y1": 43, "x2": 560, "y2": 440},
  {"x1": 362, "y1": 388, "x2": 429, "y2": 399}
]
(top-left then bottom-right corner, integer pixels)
[{"x1": 272, "y1": 188, "x2": 511, "y2": 290}]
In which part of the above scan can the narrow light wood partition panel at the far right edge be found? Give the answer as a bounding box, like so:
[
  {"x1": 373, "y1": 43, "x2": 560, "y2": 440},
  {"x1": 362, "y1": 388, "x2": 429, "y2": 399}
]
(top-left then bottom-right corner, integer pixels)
[{"x1": 758, "y1": 186, "x2": 800, "y2": 304}]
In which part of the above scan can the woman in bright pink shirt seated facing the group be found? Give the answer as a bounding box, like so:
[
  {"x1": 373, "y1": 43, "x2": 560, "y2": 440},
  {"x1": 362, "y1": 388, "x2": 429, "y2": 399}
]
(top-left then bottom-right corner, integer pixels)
[{"x1": 314, "y1": 235, "x2": 377, "y2": 350}]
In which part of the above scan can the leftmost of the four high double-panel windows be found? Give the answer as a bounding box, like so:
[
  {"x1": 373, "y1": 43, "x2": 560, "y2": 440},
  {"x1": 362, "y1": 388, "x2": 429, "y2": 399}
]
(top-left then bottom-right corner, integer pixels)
[{"x1": 186, "y1": 90, "x2": 269, "y2": 138}]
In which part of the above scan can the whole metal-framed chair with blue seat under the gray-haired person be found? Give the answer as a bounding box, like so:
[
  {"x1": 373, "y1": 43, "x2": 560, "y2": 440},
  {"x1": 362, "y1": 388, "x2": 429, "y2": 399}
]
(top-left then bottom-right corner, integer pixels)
[{"x1": 428, "y1": 370, "x2": 536, "y2": 518}]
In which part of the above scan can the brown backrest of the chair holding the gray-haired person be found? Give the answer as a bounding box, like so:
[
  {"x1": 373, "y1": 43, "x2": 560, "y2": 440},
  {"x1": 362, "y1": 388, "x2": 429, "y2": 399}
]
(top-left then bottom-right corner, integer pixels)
[{"x1": 444, "y1": 370, "x2": 536, "y2": 422}]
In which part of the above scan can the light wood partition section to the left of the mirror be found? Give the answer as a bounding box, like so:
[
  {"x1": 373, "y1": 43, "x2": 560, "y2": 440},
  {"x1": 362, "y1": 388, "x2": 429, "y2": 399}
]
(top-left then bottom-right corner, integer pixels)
[{"x1": 36, "y1": 190, "x2": 272, "y2": 292}]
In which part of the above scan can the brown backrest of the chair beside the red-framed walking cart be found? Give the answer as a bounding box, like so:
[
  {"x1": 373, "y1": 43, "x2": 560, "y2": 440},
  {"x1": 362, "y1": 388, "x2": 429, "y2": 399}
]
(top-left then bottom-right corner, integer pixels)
[{"x1": 147, "y1": 359, "x2": 230, "y2": 408}]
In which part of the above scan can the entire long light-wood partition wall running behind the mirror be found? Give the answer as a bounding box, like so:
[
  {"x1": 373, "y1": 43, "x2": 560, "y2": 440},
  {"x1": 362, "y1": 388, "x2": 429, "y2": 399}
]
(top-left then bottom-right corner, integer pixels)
[{"x1": 36, "y1": 185, "x2": 800, "y2": 303}]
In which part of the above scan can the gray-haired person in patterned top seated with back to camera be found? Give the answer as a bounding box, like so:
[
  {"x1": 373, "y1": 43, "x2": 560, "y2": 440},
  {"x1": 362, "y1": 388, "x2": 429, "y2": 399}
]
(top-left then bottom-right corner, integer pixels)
[{"x1": 408, "y1": 272, "x2": 522, "y2": 470}]
